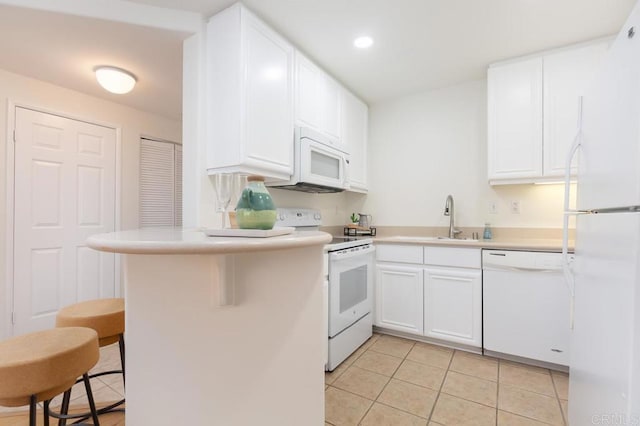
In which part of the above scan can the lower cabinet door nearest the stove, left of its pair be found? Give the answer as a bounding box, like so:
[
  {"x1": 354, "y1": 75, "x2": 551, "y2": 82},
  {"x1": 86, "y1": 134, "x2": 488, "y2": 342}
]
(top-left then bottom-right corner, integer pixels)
[{"x1": 375, "y1": 264, "x2": 423, "y2": 334}]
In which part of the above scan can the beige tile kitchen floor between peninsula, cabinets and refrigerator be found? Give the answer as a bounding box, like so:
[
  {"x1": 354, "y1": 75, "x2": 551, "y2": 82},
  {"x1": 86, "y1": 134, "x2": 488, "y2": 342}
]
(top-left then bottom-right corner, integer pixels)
[{"x1": 325, "y1": 334, "x2": 569, "y2": 426}]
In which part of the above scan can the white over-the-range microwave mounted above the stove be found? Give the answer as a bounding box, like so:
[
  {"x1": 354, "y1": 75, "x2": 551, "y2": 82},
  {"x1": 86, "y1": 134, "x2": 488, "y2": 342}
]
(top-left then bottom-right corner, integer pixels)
[{"x1": 267, "y1": 127, "x2": 349, "y2": 193}]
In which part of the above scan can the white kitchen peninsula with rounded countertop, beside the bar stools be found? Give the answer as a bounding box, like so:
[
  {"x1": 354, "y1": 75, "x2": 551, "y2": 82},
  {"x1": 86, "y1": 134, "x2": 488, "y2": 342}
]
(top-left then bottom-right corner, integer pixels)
[{"x1": 88, "y1": 228, "x2": 331, "y2": 425}]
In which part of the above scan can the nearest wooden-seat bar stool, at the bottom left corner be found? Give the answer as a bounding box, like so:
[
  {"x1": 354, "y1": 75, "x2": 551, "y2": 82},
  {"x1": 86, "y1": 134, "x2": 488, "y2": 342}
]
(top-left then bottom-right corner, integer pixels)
[{"x1": 0, "y1": 327, "x2": 100, "y2": 426}]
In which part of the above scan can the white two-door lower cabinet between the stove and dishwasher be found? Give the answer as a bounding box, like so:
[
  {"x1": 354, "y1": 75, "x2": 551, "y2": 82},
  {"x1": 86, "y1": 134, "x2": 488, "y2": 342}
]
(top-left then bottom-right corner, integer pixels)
[{"x1": 375, "y1": 244, "x2": 482, "y2": 348}]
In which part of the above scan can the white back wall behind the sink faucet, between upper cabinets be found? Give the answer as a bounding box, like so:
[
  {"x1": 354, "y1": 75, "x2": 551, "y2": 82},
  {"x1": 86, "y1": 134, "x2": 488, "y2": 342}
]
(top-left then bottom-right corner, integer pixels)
[{"x1": 362, "y1": 80, "x2": 564, "y2": 228}]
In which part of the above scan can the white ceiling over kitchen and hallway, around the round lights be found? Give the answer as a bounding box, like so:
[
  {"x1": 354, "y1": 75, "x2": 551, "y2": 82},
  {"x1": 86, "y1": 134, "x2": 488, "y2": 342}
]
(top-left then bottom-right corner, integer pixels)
[{"x1": 0, "y1": 0, "x2": 636, "y2": 119}]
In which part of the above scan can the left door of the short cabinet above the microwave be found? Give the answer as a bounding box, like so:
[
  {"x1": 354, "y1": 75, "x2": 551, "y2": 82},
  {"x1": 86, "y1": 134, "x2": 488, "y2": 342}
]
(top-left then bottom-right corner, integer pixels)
[{"x1": 295, "y1": 52, "x2": 322, "y2": 131}]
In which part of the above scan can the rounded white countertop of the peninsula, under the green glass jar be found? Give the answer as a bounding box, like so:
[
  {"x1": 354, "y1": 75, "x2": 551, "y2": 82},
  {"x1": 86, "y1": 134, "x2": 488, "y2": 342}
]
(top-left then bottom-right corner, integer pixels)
[{"x1": 87, "y1": 228, "x2": 331, "y2": 254}]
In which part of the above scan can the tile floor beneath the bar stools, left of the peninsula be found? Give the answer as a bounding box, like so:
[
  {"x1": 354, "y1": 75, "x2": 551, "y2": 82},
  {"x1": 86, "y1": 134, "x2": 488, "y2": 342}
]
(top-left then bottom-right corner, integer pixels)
[{"x1": 0, "y1": 343, "x2": 124, "y2": 416}]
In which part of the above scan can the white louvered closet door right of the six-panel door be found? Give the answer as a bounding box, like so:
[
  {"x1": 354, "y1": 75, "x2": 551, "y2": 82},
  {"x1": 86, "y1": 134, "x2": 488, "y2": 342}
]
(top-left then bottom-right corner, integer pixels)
[{"x1": 140, "y1": 139, "x2": 182, "y2": 228}]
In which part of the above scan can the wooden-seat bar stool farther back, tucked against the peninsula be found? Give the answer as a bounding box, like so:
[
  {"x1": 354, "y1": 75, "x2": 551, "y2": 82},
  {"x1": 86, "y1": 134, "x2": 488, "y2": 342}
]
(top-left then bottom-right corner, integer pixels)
[{"x1": 56, "y1": 299, "x2": 125, "y2": 425}]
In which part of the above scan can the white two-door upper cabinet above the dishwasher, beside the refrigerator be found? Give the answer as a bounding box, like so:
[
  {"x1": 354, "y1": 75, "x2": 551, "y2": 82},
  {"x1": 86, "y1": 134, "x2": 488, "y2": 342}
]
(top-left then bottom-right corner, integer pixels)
[{"x1": 487, "y1": 41, "x2": 609, "y2": 184}]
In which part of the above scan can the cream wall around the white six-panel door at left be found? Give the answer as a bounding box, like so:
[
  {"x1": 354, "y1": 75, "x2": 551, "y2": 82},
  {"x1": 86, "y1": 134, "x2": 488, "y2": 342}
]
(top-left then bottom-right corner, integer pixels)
[{"x1": 0, "y1": 70, "x2": 182, "y2": 339}]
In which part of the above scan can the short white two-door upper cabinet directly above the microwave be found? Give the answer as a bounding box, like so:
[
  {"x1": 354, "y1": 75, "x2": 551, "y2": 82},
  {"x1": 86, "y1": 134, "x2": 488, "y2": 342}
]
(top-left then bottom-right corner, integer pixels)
[{"x1": 295, "y1": 51, "x2": 341, "y2": 145}]
